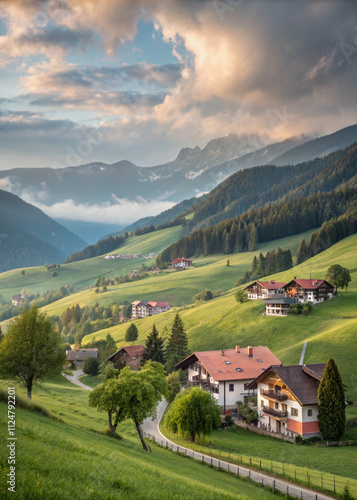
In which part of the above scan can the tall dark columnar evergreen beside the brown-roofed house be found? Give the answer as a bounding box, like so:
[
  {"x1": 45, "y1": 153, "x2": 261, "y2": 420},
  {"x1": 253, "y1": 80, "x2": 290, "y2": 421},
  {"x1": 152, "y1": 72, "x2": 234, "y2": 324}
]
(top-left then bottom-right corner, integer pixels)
[{"x1": 317, "y1": 359, "x2": 346, "y2": 441}]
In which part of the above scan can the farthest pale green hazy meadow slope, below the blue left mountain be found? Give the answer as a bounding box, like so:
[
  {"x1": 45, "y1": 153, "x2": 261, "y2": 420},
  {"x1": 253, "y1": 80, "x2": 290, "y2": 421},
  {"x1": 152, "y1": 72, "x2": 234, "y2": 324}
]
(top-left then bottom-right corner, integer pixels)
[{"x1": 0, "y1": 226, "x2": 181, "y2": 300}]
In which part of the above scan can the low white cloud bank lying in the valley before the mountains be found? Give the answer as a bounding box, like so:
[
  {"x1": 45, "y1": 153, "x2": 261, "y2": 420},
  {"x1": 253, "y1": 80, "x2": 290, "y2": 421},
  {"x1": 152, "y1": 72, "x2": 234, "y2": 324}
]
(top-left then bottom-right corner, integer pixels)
[{"x1": 22, "y1": 193, "x2": 175, "y2": 224}]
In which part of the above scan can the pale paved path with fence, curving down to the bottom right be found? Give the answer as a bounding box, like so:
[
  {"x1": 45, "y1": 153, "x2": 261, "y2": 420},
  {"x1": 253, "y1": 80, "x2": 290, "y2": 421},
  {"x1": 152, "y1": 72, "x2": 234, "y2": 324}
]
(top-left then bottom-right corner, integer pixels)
[{"x1": 142, "y1": 400, "x2": 333, "y2": 500}]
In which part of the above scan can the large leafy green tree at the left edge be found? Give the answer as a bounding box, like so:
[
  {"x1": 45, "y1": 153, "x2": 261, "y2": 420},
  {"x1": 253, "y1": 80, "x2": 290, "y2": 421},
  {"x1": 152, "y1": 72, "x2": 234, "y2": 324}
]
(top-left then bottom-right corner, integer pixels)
[{"x1": 0, "y1": 307, "x2": 66, "y2": 399}]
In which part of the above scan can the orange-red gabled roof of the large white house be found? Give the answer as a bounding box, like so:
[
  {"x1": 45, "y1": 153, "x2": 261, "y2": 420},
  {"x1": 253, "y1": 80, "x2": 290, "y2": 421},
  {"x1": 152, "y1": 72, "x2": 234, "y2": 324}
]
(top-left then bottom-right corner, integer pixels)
[{"x1": 175, "y1": 346, "x2": 280, "y2": 382}]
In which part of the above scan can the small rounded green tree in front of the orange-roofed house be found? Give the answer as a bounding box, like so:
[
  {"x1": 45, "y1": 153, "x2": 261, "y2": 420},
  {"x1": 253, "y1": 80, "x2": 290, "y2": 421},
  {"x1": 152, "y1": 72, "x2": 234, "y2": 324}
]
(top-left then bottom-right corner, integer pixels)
[{"x1": 165, "y1": 387, "x2": 221, "y2": 443}]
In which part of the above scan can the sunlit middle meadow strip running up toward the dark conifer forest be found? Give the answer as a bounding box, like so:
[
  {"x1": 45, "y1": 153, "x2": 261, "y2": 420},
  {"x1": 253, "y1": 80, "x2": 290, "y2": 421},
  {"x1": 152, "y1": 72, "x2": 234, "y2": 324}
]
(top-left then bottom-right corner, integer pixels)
[{"x1": 39, "y1": 231, "x2": 311, "y2": 314}]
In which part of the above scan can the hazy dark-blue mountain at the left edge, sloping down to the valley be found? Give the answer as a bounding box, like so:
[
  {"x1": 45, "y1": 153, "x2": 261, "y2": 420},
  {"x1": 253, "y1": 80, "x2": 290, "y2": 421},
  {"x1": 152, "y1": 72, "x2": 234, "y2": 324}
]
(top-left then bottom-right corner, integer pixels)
[{"x1": 0, "y1": 190, "x2": 85, "y2": 272}]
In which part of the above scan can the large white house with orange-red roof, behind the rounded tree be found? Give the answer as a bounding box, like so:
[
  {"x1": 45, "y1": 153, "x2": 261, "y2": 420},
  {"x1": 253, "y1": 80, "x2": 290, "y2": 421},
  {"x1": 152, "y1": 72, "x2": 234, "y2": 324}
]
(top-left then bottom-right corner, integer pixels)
[{"x1": 175, "y1": 346, "x2": 280, "y2": 411}]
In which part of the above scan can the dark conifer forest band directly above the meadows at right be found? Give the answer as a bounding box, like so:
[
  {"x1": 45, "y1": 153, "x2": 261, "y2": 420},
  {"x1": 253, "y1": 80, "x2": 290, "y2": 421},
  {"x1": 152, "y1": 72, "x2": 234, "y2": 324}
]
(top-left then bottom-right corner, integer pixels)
[{"x1": 157, "y1": 187, "x2": 357, "y2": 266}]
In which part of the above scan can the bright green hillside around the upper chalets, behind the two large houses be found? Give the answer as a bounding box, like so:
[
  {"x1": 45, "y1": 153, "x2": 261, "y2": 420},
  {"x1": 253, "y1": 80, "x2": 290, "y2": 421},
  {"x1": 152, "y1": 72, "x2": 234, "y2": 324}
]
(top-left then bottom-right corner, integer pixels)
[{"x1": 80, "y1": 235, "x2": 357, "y2": 400}]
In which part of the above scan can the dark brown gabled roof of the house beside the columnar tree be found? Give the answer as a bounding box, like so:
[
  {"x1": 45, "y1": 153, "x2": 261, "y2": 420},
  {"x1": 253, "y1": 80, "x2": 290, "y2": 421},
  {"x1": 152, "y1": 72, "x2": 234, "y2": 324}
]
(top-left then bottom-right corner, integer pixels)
[{"x1": 249, "y1": 363, "x2": 326, "y2": 406}]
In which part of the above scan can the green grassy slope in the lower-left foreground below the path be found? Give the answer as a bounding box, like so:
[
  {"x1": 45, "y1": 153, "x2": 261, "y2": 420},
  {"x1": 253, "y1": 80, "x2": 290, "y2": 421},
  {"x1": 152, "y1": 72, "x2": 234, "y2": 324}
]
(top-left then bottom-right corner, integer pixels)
[{"x1": 0, "y1": 379, "x2": 273, "y2": 500}]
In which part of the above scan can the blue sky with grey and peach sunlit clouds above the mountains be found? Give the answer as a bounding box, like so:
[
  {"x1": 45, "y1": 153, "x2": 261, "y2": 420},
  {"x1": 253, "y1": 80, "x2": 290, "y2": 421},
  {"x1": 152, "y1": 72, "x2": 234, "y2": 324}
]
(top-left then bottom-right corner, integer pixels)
[{"x1": 0, "y1": 0, "x2": 357, "y2": 170}]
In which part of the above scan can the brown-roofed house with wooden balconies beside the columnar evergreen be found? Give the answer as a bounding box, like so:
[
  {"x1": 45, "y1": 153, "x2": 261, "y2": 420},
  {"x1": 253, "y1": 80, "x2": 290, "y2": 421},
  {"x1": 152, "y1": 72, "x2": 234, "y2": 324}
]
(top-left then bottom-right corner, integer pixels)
[{"x1": 249, "y1": 363, "x2": 326, "y2": 439}]
